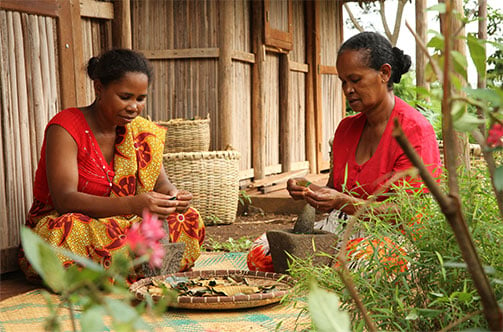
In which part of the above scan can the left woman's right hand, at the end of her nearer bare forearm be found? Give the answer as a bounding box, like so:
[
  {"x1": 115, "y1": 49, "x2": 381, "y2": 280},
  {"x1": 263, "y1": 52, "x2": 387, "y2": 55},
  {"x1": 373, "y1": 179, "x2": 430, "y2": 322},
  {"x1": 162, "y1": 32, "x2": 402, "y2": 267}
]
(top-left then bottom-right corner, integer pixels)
[{"x1": 132, "y1": 191, "x2": 178, "y2": 219}]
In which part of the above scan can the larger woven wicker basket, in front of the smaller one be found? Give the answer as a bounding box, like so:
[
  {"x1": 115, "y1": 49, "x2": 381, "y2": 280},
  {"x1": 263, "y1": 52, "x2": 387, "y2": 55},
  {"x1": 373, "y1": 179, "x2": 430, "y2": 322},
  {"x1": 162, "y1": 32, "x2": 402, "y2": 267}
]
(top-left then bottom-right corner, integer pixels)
[{"x1": 163, "y1": 151, "x2": 240, "y2": 225}]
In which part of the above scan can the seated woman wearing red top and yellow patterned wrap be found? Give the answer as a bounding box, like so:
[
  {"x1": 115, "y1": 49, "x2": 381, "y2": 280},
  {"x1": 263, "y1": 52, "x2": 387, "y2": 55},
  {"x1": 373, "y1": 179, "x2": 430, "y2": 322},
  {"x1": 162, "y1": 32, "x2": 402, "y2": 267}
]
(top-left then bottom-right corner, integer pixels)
[{"x1": 20, "y1": 49, "x2": 205, "y2": 279}]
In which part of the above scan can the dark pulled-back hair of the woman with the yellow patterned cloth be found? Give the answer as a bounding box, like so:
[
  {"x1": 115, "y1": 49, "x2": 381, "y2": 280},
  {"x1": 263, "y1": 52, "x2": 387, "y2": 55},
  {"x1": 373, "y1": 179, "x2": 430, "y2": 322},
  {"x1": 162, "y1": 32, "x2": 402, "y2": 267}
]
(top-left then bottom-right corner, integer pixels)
[{"x1": 87, "y1": 49, "x2": 154, "y2": 86}]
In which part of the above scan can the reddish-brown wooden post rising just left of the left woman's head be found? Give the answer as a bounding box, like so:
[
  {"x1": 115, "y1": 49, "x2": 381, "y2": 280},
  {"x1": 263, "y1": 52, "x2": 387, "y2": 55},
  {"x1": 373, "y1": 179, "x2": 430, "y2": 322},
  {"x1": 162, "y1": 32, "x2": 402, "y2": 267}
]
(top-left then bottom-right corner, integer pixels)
[{"x1": 57, "y1": 0, "x2": 86, "y2": 108}]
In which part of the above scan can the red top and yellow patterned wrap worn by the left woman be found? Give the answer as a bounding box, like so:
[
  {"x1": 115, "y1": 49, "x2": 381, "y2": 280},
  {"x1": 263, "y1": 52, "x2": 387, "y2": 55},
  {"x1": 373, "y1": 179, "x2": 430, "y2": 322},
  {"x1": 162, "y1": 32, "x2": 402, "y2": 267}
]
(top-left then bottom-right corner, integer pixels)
[{"x1": 19, "y1": 108, "x2": 205, "y2": 279}]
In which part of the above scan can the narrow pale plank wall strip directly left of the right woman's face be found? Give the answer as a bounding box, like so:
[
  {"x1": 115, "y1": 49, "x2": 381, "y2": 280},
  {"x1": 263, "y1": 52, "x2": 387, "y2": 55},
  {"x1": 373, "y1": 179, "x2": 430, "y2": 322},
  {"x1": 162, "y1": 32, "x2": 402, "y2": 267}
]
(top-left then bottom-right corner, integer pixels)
[{"x1": 319, "y1": 1, "x2": 344, "y2": 168}]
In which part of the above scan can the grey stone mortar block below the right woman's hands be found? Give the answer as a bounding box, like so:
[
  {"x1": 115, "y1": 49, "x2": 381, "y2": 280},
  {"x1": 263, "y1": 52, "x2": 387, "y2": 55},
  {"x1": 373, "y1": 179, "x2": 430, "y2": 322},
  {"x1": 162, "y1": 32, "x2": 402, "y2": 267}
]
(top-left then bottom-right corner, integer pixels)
[{"x1": 266, "y1": 230, "x2": 337, "y2": 273}]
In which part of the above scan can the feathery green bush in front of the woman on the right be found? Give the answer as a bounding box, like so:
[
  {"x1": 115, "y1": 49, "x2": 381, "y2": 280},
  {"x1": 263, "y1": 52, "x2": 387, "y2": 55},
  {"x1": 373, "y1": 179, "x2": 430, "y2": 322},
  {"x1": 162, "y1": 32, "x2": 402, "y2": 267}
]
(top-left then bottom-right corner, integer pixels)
[{"x1": 290, "y1": 168, "x2": 503, "y2": 331}]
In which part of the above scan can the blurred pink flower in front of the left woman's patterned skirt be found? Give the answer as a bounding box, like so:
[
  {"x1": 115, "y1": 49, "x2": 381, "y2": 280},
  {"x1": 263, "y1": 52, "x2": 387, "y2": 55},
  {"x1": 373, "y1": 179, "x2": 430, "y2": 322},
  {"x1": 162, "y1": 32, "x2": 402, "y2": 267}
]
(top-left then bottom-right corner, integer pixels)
[{"x1": 127, "y1": 210, "x2": 166, "y2": 267}]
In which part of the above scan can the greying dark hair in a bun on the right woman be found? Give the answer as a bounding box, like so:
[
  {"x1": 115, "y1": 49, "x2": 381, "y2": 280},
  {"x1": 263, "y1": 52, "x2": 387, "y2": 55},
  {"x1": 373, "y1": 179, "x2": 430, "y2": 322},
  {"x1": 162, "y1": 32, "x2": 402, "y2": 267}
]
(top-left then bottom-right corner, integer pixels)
[{"x1": 337, "y1": 31, "x2": 411, "y2": 89}]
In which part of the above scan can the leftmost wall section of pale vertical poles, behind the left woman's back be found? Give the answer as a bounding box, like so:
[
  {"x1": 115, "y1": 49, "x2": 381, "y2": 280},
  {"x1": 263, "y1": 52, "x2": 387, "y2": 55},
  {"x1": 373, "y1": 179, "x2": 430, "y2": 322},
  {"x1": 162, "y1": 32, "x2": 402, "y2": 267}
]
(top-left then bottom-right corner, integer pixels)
[{"x1": 0, "y1": 10, "x2": 60, "y2": 272}]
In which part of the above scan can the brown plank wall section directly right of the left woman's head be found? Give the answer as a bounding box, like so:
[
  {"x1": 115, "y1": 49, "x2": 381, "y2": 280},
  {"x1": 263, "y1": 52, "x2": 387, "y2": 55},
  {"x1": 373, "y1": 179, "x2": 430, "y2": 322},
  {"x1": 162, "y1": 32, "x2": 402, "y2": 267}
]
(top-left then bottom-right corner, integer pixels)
[{"x1": 131, "y1": 0, "x2": 219, "y2": 149}]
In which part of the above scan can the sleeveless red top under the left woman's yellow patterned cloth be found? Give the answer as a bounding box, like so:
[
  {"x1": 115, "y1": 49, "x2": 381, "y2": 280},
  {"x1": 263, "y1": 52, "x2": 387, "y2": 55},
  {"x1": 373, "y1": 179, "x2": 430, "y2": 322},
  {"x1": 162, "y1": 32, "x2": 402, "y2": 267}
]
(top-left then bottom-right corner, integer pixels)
[{"x1": 33, "y1": 108, "x2": 115, "y2": 205}]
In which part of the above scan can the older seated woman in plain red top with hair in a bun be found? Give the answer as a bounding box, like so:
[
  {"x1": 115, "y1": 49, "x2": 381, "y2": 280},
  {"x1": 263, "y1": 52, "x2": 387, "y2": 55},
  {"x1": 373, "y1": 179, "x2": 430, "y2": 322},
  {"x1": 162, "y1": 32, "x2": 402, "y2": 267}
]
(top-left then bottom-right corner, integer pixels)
[{"x1": 248, "y1": 32, "x2": 441, "y2": 269}]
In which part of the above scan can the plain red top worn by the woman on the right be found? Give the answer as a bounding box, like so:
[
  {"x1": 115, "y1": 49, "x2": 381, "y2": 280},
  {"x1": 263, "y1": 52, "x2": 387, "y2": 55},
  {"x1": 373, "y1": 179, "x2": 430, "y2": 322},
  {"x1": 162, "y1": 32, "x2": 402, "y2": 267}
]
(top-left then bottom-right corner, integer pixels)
[{"x1": 332, "y1": 97, "x2": 441, "y2": 199}]
